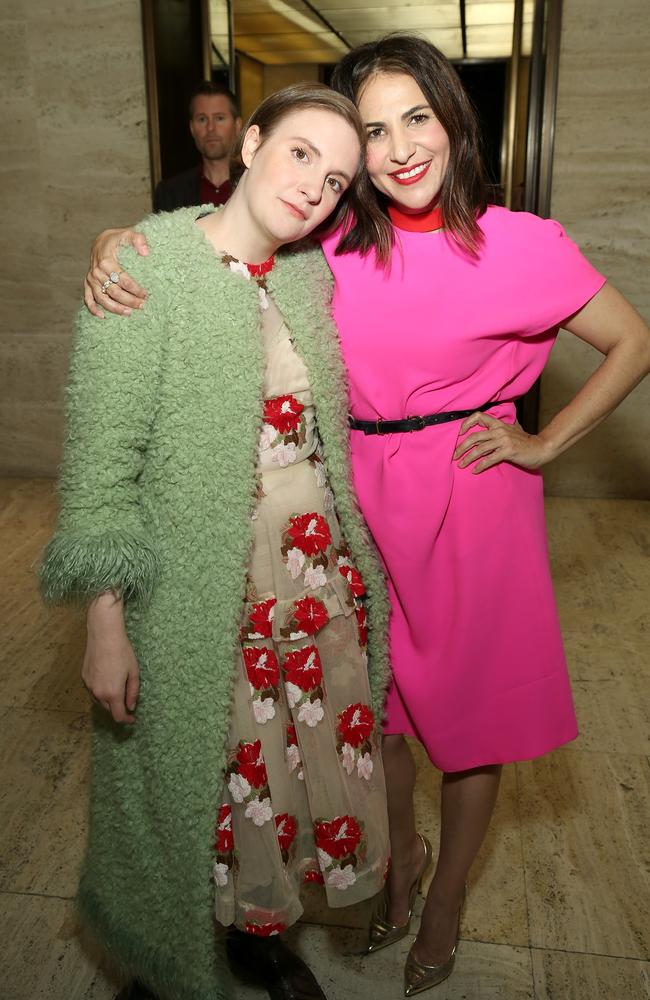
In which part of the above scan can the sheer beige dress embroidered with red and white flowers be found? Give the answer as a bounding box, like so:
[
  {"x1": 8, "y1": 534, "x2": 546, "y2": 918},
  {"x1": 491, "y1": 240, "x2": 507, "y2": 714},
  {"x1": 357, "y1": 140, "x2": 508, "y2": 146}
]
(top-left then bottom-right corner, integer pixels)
[{"x1": 214, "y1": 255, "x2": 389, "y2": 935}]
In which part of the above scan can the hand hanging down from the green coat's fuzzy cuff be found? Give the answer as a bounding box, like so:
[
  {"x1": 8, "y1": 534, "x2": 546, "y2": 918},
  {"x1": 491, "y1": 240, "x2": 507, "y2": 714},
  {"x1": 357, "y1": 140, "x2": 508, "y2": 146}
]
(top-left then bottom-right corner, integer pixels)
[{"x1": 81, "y1": 594, "x2": 140, "y2": 723}]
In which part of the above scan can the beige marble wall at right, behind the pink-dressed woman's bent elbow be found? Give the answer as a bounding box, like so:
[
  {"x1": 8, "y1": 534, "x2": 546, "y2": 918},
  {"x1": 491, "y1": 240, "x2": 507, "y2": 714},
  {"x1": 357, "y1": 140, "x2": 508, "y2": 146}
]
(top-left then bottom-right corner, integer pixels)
[{"x1": 541, "y1": 0, "x2": 650, "y2": 498}]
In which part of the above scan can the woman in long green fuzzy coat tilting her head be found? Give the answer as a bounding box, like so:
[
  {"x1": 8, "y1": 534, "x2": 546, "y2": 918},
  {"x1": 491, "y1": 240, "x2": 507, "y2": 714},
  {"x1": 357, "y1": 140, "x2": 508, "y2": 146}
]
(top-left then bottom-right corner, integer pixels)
[{"x1": 42, "y1": 85, "x2": 388, "y2": 1000}]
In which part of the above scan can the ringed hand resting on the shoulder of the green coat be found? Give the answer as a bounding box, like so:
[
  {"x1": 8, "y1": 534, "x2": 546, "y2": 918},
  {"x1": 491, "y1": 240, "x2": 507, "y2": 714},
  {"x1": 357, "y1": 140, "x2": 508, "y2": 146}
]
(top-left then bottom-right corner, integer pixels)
[{"x1": 84, "y1": 229, "x2": 149, "y2": 319}]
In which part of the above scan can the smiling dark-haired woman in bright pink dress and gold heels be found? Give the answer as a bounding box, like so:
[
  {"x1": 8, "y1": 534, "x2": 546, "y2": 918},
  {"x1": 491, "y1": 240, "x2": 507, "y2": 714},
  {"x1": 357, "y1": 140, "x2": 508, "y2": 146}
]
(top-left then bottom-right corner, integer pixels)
[{"x1": 86, "y1": 35, "x2": 650, "y2": 996}]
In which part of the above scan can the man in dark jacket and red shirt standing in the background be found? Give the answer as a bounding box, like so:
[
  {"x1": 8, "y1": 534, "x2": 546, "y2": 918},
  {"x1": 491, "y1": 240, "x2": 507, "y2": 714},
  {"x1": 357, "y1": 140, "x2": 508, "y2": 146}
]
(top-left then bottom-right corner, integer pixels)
[{"x1": 153, "y1": 81, "x2": 242, "y2": 212}]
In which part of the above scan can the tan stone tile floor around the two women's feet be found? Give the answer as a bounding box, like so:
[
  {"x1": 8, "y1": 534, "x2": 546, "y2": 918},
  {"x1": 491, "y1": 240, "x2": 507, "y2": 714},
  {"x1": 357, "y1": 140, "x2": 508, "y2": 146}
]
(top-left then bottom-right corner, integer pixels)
[{"x1": 0, "y1": 480, "x2": 650, "y2": 1000}]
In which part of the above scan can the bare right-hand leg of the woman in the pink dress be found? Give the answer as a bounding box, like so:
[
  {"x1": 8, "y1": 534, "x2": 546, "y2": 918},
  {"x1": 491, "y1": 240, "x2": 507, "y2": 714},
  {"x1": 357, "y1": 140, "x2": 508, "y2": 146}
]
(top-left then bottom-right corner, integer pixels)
[{"x1": 413, "y1": 764, "x2": 501, "y2": 965}]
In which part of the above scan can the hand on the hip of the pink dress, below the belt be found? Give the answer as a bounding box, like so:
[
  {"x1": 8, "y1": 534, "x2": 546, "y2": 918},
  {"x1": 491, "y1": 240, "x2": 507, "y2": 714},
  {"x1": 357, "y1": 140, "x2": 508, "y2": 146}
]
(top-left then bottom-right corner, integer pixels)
[{"x1": 454, "y1": 413, "x2": 554, "y2": 475}]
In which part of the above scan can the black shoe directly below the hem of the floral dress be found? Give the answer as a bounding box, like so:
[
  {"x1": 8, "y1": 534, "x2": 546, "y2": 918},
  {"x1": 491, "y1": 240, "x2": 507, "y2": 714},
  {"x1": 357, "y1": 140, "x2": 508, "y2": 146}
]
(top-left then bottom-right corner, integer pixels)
[{"x1": 226, "y1": 928, "x2": 327, "y2": 1000}]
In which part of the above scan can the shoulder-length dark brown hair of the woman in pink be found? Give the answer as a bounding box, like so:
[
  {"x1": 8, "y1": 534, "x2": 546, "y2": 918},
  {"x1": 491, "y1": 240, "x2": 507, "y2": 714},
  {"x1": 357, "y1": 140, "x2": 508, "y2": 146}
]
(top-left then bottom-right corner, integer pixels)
[{"x1": 332, "y1": 32, "x2": 488, "y2": 262}]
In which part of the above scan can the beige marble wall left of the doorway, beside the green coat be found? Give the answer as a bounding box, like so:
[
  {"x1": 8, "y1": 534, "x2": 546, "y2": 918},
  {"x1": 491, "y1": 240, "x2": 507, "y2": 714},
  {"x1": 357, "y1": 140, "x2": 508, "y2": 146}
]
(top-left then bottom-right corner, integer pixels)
[{"x1": 0, "y1": 0, "x2": 150, "y2": 475}]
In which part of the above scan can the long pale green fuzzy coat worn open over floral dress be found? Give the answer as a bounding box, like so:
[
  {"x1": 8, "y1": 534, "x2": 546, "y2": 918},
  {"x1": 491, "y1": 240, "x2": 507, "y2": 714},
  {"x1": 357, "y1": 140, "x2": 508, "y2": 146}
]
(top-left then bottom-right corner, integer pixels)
[{"x1": 42, "y1": 209, "x2": 388, "y2": 1000}]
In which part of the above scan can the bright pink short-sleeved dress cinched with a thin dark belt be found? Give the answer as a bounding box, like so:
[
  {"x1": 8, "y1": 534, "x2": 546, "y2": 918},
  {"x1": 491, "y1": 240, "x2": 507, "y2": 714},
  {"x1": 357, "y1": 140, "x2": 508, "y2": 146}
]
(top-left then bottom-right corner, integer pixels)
[{"x1": 323, "y1": 207, "x2": 605, "y2": 771}]
